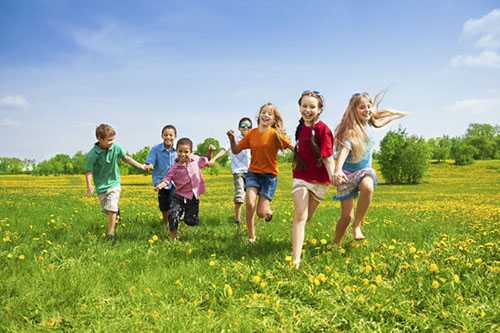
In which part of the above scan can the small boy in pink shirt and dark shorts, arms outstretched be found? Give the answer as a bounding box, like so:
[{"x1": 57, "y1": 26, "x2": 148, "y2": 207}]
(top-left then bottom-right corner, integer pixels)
[{"x1": 156, "y1": 138, "x2": 224, "y2": 239}]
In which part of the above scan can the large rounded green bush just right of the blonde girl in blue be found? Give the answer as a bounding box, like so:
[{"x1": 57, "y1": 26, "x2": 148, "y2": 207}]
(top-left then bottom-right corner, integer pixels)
[{"x1": 378, "y1": 129, "x2": 430, "y2": 184}]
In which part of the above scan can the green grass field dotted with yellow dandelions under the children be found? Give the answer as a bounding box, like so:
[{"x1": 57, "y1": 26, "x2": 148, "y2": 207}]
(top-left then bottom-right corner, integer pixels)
[{"x1": 0, "y1": 161, "x2": 500, "y2": 332}]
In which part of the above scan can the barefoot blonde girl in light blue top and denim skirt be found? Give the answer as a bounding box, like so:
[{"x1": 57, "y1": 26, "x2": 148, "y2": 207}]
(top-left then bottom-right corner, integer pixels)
[{"x1": 334, "y1": 93, "x2": 406, "y2": 245}]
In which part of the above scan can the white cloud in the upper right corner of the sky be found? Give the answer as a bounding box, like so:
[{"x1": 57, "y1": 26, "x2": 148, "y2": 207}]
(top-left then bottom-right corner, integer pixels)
[{"x1": 463, "y1": 9, "x2": 500, "y2": 50}]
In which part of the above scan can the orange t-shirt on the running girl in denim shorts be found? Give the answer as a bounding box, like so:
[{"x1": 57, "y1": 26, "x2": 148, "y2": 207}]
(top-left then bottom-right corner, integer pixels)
[{"x1": 238, "y1": 127, "x2": 291, "y2": 176}]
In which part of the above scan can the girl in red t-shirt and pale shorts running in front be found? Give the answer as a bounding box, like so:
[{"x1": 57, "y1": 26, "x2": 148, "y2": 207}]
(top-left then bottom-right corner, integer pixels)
[{"x1": 292, "y1": 90, "x2": 334, "y2": 268}]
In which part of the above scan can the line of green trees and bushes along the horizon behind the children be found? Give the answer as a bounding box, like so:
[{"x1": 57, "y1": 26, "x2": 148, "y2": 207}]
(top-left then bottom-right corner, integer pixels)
[{"x1": 0, "y1": 123, "x2": 500, "y2": 179}]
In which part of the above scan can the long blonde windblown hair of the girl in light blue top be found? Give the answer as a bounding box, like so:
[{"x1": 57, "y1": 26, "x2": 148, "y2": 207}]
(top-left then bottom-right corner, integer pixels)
[{"x1": 335, "y1": 92, "x2": 406, "y2": 162}]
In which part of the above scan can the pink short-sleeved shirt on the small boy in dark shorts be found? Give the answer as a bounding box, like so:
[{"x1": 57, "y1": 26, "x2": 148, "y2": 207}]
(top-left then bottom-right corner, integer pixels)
[{"x1": 163, "y1": 155, "x2": 208, "y2": 199}]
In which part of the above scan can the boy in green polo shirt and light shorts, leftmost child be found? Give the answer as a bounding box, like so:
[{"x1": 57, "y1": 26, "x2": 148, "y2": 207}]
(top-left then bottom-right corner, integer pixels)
[{"x1": 85, "y1": 124, "x2": 150, "y2": 242}]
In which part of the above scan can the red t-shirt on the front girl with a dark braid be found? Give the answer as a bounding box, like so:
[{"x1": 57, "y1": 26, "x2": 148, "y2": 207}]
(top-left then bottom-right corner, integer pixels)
[{"x1": 293, "y1": 121, "x2": 333, "y2": 184}]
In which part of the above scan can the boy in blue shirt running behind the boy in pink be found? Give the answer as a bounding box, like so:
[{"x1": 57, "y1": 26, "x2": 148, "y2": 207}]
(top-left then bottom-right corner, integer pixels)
[{"x1": 146, "y1": 125, "x2": 177, "y2": 231}]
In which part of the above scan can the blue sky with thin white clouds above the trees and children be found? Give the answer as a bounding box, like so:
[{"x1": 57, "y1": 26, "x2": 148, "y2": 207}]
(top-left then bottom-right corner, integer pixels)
[{"x1": 0, "y1": 0, "x2": 500, "y2": 161}]
